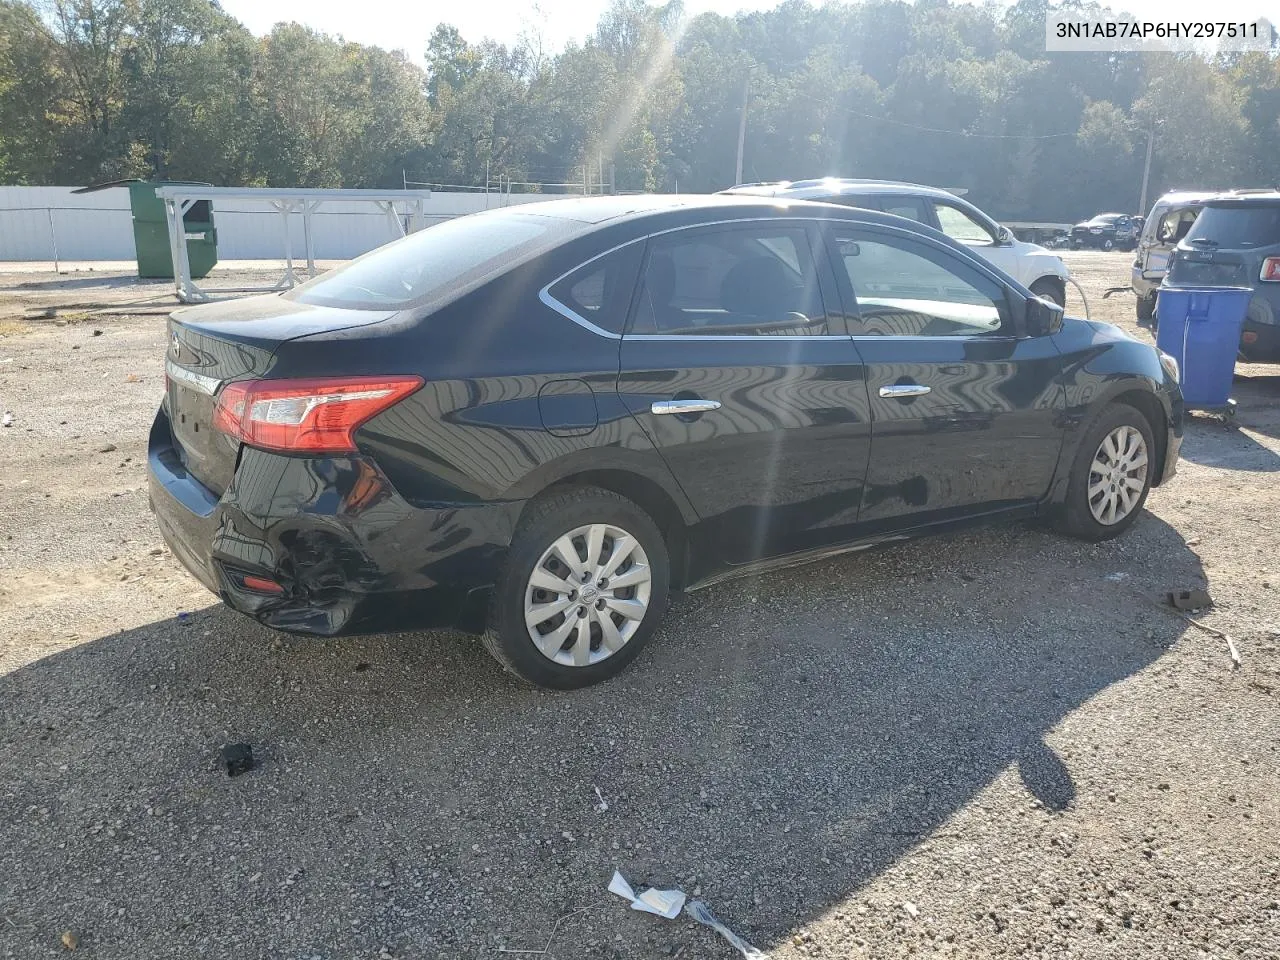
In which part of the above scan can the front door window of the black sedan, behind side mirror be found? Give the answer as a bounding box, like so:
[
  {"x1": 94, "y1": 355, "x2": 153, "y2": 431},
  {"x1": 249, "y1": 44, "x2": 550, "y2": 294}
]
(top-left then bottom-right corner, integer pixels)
[{"x1": 836, "y1": 232, "x2": 1005, "y2": 337}]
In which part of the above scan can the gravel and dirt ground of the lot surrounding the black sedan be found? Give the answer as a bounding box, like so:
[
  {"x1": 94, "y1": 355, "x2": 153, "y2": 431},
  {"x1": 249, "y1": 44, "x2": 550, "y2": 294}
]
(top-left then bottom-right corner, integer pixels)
[{"x1": 0, "y1": 253, "x2": 1280, "y2": 960}]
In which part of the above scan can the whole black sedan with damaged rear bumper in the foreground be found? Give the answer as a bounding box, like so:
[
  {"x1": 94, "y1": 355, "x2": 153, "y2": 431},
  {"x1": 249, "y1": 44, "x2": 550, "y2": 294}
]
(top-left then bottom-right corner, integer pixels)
[{"x1": 150, "y1": 197, "x2": 1183, "y2": 687}]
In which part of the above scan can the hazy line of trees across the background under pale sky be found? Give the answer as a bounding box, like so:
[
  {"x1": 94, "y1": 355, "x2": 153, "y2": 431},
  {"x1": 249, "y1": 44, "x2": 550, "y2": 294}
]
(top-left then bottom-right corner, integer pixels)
[{"x1": 0, "y1": 0, "x2": 1280, "y2": 220}]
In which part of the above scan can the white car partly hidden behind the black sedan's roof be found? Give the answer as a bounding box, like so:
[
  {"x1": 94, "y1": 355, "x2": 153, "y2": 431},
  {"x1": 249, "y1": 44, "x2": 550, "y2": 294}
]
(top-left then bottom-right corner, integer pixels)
[{"x1": 722, "y1": 177, "x2": 1069, "y2": 306}]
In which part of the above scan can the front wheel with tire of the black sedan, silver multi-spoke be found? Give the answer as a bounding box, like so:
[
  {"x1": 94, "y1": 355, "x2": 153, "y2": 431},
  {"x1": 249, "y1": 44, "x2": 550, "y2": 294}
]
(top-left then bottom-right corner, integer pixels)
[{"x1": 1059, "y1": 403, "x2": 1156, "y2": 541}]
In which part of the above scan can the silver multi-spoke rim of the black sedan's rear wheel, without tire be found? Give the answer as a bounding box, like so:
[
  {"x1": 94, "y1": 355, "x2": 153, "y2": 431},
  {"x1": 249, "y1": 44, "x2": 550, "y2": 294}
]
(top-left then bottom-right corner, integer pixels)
[{"x1": 525, "y1": 524, "x2": 653, "y2": 667}]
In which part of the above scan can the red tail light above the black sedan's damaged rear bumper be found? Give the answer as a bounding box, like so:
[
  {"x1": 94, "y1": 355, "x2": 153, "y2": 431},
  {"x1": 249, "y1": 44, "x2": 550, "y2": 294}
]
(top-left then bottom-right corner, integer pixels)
[{"x1": 214, "y1": 376, "x2": 422, "y2": 453}]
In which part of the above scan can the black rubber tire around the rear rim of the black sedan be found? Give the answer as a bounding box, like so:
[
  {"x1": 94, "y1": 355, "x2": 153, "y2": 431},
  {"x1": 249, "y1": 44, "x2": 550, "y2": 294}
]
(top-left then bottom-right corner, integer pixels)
[{"x1": 484, "y1": 486, "x2": 671, "y2": 690}]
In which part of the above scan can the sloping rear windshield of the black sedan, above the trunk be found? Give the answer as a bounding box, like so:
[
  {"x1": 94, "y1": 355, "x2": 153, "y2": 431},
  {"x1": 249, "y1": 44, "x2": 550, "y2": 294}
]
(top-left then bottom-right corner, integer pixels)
[{"x1": 284, "y1": 211, "x2": 573, "y2": 310}]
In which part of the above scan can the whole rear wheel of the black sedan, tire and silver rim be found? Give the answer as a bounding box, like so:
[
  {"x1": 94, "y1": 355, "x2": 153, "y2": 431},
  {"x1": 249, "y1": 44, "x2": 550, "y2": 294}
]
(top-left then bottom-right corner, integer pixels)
[{"x1": 484, "y1": 486, "x2": 671, "y2": 690}]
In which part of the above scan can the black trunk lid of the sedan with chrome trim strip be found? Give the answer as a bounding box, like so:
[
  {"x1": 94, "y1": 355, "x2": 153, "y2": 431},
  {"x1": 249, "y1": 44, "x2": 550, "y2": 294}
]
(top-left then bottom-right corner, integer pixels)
[{"x1": 165, "y1": 296, "x2": 394, "y2": 495}]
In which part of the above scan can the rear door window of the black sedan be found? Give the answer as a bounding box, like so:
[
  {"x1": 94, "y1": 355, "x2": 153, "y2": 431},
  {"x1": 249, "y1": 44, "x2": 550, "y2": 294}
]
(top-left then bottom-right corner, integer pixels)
[{"x1": 631, "y1": 224, "x2": 828, "y2": 337}]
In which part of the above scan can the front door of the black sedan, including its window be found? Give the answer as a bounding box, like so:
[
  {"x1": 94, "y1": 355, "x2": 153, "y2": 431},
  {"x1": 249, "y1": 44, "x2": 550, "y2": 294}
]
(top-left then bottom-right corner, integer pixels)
[{"x1": 828, "y1": 225, "x2": 1065, "y2": 534}]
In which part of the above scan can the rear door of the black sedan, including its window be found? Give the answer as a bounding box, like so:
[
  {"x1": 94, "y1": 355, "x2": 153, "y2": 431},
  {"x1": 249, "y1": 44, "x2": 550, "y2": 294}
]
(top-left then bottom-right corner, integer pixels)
[{"x1": 618, "y1": 219, "x2": 870, "y2": 563}]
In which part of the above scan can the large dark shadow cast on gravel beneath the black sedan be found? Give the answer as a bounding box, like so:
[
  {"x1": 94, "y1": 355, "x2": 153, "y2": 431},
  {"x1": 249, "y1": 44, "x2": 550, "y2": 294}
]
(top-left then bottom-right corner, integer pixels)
[{"x1": 0, "y1": 516, "x2": 1202, "y2": 957}]
